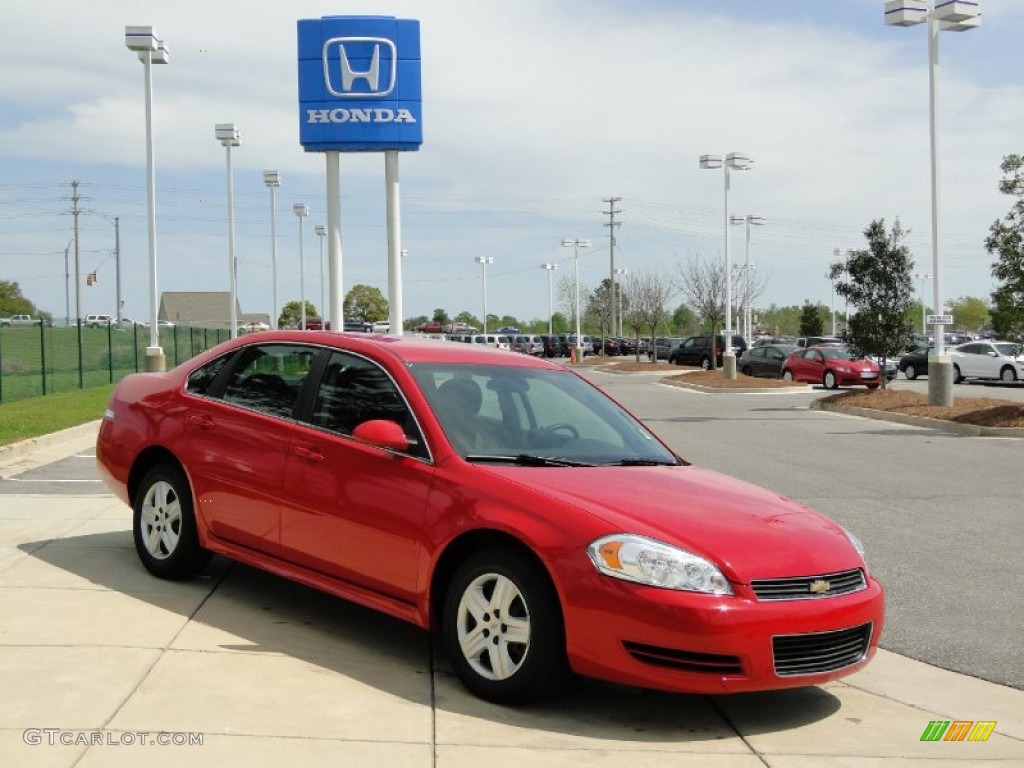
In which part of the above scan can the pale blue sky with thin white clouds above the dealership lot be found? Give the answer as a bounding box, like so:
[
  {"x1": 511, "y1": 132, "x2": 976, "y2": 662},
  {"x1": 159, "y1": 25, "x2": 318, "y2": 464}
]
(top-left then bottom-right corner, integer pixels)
[{"x1": 0, "y1": 0, "x2": 1024, "y2": 321}]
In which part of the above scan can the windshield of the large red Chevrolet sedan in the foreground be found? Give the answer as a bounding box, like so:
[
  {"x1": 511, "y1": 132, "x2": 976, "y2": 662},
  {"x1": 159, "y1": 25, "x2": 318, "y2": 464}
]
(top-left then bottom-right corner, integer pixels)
[{"x1": 410, "y1": 362, "x2": 680, "y2": 466}]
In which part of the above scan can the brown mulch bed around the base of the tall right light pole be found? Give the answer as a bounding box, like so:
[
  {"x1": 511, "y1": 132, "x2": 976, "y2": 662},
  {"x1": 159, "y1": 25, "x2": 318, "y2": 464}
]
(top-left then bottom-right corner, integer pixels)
[{"x1": 822, "y1": 389, "x2": 1024, "y2": 427}]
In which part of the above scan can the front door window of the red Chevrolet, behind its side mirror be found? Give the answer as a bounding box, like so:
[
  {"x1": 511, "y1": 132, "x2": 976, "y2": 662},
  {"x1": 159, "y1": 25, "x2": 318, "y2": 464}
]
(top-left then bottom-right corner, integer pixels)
[{"x1": 312, "y1": 352, "x2": 425, "y2": 456}]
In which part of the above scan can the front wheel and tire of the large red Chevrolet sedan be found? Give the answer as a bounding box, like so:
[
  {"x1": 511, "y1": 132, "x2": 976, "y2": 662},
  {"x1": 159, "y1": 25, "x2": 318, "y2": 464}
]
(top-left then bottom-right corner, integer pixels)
[{"x1": 441, "y1": 548, "x2": 568, "y2": 705}]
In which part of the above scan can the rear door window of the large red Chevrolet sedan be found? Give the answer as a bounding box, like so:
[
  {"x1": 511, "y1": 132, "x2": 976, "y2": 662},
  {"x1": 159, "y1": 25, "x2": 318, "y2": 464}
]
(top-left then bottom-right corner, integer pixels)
[{"x1": 217, "y1": 344, "x2": 316, "y2": 418}]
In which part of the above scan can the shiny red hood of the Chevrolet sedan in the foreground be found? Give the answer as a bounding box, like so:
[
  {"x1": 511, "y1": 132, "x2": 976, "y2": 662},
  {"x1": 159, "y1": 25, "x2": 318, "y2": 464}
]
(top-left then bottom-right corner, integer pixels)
[{"x1": 478, "y1": 465, "x2": 863, "y2": 584}]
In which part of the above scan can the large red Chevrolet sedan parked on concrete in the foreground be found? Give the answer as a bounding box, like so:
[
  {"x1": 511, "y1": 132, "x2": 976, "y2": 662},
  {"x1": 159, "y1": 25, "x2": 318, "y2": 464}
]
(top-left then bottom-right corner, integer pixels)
[{"x1": 96, "y1": 331, "x2": 884, "y2": 703}]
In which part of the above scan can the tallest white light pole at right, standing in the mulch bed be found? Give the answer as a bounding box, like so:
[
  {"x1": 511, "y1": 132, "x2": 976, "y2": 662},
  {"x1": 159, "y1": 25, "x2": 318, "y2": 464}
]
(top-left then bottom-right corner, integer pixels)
[{"x1": 885, "y1": 0, "x2": 981, "y2": 407}]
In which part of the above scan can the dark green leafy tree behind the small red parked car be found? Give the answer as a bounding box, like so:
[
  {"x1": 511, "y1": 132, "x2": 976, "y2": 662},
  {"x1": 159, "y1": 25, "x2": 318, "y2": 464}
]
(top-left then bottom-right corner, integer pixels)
[{"x1": 829, "y1": 219, "x2": 913, "y2": 387}]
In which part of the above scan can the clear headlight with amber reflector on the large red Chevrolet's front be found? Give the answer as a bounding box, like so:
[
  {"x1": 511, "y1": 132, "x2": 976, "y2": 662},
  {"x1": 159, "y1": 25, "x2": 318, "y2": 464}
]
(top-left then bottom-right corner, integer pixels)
[{"x1": 587, "y1": 534, "x2": 732, "y2": 595}]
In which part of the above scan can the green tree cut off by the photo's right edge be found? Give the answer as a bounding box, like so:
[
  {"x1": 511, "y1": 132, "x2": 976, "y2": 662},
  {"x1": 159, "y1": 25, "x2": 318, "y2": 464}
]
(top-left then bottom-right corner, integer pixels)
[{"x1": 985, "y1": 155, "x2": 1024, "y2": 338}]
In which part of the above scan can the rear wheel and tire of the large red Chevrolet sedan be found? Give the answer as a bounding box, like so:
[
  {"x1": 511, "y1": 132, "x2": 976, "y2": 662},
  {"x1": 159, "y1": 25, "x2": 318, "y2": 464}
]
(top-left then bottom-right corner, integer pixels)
[{"x1": 132, "y1": 465, "x2": 211, "y2": 580}]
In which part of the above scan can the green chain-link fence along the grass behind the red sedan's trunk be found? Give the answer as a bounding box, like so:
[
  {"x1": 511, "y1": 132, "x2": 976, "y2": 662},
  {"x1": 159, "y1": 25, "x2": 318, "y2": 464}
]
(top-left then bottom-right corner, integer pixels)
[{"x1": 0, "y1": 326, "x2": 229, "y2": 403}]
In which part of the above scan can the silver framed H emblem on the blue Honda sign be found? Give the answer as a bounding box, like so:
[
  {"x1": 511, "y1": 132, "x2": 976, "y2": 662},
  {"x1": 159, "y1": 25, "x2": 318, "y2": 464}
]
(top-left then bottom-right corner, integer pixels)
[{"x1": 324, "y1": 37, "x2": 398, "y2": 98}]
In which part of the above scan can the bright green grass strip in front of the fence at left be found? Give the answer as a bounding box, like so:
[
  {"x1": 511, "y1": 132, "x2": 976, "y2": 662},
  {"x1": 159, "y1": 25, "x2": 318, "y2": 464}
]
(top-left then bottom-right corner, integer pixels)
[{"x1": 0, "y1": 384, "x2": 114, "y2": 445}]
